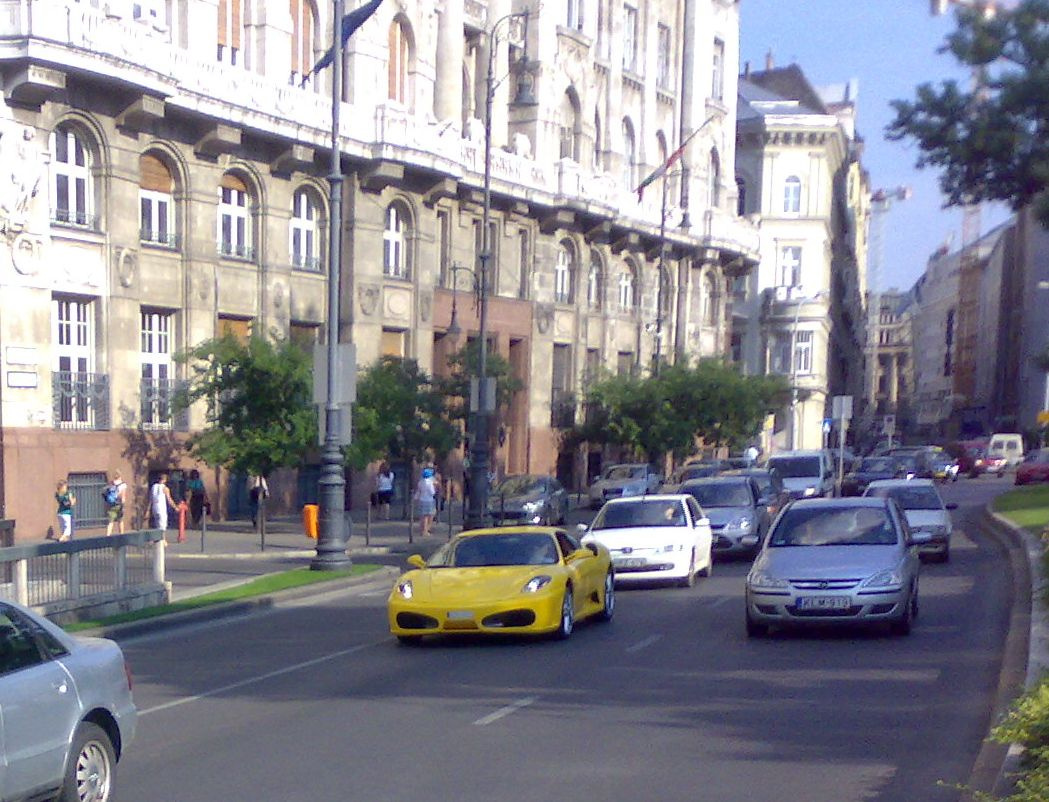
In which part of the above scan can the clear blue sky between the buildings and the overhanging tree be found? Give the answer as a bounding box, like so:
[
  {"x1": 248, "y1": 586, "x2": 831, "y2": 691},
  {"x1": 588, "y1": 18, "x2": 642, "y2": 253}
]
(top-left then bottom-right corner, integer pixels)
[{"x1": 740, "y1": 0, "x2": 1008, "y2": 289}]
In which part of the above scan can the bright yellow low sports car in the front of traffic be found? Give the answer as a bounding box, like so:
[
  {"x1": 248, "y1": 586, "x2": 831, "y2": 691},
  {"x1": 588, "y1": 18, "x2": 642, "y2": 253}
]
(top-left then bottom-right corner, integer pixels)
[{"x1": 387, "y1": 526, "x2": 616, "y2": 644}]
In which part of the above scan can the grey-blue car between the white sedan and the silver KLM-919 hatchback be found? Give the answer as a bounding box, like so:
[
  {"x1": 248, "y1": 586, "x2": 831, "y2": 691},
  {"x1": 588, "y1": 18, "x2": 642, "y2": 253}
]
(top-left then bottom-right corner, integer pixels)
[{"x1": 681, "y1": 476, "x2": 769, "y2": 555}]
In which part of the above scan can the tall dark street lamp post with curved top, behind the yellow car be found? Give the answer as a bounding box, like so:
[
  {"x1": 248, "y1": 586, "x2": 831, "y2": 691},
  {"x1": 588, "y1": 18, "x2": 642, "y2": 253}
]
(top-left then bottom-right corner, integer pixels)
[{"x1": 466, "y1": 10, "x2": 535, "y2": 528}]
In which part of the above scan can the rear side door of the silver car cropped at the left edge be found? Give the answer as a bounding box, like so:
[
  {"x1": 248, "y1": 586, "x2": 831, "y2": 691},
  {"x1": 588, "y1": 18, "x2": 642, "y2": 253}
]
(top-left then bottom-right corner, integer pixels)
[{"x1": 0, "y1": 603, "x2": 80, "y2": 799}]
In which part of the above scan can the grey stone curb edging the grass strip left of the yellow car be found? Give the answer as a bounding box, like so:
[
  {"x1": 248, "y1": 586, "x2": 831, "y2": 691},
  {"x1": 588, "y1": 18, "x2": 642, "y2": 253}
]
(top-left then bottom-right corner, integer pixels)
[{"x1": 77, "y1": 566, "x2": 401, "y2": 640}]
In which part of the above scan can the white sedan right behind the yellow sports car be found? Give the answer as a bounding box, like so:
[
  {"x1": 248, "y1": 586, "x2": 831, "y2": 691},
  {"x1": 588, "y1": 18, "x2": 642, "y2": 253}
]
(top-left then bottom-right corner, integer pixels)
[{"x1": 582, "y1": 495, "x2": 713, "y2": 587}]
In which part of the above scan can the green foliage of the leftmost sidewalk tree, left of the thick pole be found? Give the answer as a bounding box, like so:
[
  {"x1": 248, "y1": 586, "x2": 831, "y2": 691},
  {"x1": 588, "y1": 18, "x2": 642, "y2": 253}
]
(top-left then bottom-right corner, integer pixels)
[{"x1": 173, "y1": 334, "x2": 317, "y2": 476}]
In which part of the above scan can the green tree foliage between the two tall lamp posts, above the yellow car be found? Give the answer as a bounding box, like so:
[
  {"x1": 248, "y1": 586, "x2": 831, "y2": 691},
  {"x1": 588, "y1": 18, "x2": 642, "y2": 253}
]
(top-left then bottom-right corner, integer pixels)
[{"x1": 346, "y1": 356, "x2": 458, "y2": 469}]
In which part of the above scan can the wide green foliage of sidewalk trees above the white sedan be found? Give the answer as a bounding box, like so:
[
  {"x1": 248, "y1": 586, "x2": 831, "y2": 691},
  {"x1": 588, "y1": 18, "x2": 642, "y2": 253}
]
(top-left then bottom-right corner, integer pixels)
[{"x1": 565, "y1": 360, "x2": 789, "y2": 461}]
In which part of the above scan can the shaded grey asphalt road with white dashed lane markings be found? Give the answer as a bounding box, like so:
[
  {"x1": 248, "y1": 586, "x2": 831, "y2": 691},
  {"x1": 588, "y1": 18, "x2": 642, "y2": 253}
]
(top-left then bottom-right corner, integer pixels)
[{"x1": 117, "y1": 479, "x2": 1011, "y2": 802}]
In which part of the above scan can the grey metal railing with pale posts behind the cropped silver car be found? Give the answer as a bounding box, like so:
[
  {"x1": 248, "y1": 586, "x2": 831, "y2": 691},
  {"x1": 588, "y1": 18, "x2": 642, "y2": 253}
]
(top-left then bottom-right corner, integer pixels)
[{"x1": 0, "y1": 529, "x2": 165, "y2": 607}]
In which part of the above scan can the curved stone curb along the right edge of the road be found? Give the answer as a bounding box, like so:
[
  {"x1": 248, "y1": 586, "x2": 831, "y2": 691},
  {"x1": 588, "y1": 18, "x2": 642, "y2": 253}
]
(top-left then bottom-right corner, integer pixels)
[{"x1": 961, "y1": 504, "x2": 1049, "y2": 802}]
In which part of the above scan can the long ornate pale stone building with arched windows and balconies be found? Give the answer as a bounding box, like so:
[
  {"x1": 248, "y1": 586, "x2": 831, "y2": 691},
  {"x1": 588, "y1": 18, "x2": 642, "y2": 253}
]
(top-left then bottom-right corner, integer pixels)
[{"x1": 0, "y1": 0, "x2": 758, "y2": 538}]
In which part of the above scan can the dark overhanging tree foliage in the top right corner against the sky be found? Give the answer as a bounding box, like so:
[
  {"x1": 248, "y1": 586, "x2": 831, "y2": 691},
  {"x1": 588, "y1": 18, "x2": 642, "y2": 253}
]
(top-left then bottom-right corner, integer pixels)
[{"x1": 886, "y1": 0, "x2": 1049, "y2": 225}]
